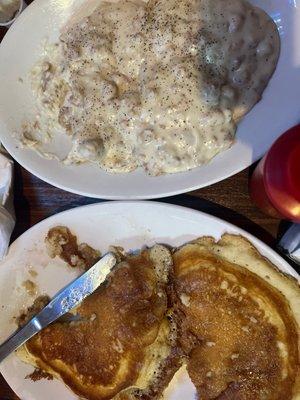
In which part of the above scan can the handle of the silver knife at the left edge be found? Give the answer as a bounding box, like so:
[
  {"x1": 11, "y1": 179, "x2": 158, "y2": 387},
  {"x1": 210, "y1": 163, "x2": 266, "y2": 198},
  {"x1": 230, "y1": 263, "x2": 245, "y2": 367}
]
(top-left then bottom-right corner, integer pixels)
[{"x1": 0, "y1": 317, "x2": 42, "y2": 363}]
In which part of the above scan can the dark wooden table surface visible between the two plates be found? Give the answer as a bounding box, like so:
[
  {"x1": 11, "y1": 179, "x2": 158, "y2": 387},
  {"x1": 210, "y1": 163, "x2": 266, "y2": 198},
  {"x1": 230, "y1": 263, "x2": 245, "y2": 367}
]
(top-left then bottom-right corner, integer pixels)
[{"x1": 0, "y1": 7, "x2": 296, "y2": 400}]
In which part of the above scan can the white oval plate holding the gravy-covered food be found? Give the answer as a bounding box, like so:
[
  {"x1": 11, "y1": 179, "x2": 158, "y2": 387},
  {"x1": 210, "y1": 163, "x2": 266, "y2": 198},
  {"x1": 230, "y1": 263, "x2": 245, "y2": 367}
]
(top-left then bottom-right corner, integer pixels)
[{"x1": 0, "y1": 0, "x2": 300, "y2": 200}]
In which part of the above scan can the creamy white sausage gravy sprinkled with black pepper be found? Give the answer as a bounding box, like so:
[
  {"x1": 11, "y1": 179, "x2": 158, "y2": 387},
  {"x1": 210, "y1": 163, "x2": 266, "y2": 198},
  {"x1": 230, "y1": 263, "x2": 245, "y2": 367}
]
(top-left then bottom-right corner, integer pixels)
[{"x1": 24, "y1": 0, "x2": 280, "y2": 175}]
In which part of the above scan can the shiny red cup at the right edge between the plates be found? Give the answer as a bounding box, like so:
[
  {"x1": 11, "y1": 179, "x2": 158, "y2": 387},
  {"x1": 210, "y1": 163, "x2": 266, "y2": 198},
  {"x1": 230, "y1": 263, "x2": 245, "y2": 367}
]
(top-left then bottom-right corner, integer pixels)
[{"x1": 249, "y1": 125, "x2": 300, "y2": 223}]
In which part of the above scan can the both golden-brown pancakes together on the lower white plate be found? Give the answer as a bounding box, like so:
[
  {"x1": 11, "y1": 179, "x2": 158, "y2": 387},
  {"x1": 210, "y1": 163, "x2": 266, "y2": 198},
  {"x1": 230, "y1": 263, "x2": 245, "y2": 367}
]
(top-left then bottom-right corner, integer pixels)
[{"x1": 19, "y1": 227, "x2": 300, "y2": 400}]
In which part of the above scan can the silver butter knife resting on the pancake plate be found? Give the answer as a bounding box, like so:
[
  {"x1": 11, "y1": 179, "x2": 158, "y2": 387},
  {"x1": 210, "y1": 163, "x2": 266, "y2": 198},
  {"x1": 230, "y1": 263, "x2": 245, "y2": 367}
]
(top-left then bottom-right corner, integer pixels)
[{"x1": 0, "y1": 253, "x2": 117, "y2": 363}]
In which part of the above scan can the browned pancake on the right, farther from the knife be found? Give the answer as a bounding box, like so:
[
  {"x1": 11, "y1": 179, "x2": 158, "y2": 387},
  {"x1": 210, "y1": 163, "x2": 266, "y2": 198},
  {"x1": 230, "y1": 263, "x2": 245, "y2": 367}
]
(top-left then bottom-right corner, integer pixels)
[{"x1": 173, "y1": 234, "x2": 300, "y2": 400}]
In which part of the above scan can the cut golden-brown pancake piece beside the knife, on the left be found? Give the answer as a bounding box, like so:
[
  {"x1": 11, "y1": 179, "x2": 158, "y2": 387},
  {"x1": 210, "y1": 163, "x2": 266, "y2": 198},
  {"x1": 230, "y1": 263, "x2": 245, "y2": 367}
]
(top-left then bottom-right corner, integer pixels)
[{"x1": 22, "y1": 245, "x2": 177, "y2": 400}]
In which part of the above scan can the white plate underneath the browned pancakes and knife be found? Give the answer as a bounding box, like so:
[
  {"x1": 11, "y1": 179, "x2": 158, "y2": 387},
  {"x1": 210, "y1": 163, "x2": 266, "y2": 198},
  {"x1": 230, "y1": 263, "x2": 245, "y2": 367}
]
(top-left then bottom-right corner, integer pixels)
[{"x1": 0, "y1": 202, "x2": 299, "y2": 400}]
